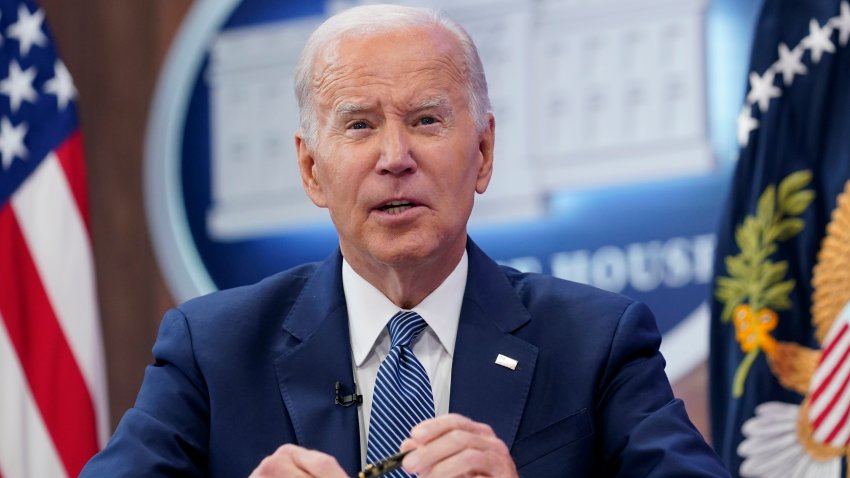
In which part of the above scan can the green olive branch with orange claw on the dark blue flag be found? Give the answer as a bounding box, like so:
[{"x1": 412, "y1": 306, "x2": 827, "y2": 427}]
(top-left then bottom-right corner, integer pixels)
[{"x1": 714, "y1": 170, "x2": 815, "y2": 398}]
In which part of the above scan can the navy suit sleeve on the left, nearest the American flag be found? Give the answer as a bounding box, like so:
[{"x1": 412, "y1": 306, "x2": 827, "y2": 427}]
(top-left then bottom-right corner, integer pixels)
[{"x1": 80, "y1": 309, "x2": 209, "y2": 477}]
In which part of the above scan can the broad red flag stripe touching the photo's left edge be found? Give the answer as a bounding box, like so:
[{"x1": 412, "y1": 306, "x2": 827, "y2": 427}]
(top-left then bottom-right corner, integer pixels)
[{"x1": 0, "y1": 205, "x2": 98, "y2": 476}]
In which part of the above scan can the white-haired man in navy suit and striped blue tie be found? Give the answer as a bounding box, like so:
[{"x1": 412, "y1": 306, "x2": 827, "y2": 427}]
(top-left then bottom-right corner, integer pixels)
[{"x1": 83, "y1": 6, "x2": 726, "y2": 478}]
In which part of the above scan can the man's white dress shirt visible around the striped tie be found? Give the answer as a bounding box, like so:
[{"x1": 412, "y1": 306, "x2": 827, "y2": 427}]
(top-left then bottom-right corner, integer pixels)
[{"x1": 342, "y1": 251, "x2": 468, "y2": 466}]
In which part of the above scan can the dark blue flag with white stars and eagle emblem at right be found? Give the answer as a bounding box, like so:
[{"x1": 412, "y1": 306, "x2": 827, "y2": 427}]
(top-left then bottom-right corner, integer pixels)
[{"x1": 709, "y1": 0, "x2": 850, "y2": 478}]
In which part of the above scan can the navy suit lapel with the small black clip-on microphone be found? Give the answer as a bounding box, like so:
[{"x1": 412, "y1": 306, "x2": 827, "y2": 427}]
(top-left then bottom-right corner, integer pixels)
[{"x1": 275, "y1": 252, "x2": 360, "y2": 475}]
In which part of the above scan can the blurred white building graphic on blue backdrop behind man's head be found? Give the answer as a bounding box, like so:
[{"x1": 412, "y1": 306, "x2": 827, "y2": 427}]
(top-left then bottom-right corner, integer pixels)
[{"x1": 207, "y1": 0, "x2": 714, "y2": 240}]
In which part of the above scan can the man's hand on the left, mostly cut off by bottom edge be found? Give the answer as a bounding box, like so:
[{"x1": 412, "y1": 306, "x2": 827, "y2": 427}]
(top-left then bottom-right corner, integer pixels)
[{"x1": 248, "y1": 444, "x2": 348, "y2": 478}]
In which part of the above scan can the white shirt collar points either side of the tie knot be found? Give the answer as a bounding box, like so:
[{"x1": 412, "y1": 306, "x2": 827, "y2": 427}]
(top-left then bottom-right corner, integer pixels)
[{"x1": 342, "y1": 251, "x2": 468, "y2": 367}]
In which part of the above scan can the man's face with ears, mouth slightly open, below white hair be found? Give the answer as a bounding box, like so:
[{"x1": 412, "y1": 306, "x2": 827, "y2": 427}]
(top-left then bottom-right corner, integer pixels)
[{"x1": 296, "y1": 28, "x2": 495, "y2": 268}]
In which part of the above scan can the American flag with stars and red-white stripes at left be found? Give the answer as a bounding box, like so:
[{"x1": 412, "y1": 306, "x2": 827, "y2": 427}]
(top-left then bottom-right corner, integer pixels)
[{"x1": 0, "y1": 0, "x2": 109, "y2": 478}]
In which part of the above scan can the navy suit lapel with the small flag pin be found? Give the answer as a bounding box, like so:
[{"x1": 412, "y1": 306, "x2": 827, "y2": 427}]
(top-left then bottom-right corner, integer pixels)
[{"x1": 449, "y1": 240, "x2": 537, "y2": 448}]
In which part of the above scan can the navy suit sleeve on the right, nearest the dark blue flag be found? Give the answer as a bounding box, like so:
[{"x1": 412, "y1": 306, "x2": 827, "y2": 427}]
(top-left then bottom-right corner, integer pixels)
[{"x1": 598, "y1": 303, "x2": 729, "y2": 477}]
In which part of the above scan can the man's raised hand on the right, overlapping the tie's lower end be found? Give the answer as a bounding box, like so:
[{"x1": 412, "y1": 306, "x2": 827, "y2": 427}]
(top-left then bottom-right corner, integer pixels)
[{"x1": 401, "y1": 414, "x2": 518, "y2": 478}]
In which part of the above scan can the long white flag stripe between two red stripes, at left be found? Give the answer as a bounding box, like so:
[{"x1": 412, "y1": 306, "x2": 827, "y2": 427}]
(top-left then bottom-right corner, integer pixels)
[{"x1": 12, "y1": 148, "x2": 109, "y2": 445}]
